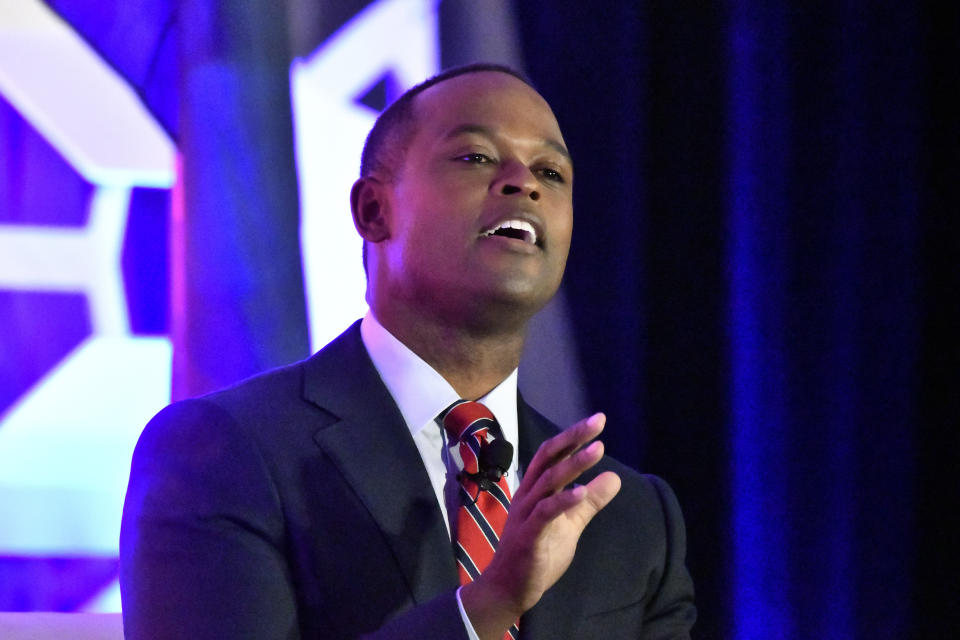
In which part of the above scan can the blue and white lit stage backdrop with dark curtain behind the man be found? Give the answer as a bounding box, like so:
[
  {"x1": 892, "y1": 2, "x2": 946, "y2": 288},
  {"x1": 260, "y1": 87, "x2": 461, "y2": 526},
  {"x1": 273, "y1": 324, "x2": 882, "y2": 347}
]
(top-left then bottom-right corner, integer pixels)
[{"x1": 0, "y1": 0, "x2": 960, "y2": 639}]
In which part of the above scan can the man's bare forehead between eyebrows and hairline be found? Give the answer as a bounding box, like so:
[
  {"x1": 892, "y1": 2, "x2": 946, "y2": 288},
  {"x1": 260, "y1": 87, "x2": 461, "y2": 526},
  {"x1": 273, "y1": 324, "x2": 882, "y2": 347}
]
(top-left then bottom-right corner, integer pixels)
[{"x1": 406, "y1": 71, "x2": 563, "y2": 146}]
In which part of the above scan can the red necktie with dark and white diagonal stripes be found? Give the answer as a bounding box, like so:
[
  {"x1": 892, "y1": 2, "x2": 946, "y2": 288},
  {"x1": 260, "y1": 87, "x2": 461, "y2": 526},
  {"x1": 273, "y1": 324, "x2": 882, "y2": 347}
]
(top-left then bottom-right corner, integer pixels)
[{"x1": 441, "y1": 400, "x2": 519, "y2": 640}]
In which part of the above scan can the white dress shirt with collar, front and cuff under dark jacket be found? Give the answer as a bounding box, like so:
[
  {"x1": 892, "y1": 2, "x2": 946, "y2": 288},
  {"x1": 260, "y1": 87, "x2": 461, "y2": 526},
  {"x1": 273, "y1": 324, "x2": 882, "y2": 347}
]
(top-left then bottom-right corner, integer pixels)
[{"x1": 360, "y1": 311, "x2": 519, "y2": 640}]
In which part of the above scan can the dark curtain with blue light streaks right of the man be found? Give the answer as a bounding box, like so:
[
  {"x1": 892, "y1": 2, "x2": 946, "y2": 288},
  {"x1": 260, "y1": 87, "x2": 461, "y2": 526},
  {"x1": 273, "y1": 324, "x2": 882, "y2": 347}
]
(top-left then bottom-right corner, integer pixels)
[{"x1": 515, "y1": 0, "x2": 960, "y2": 639}]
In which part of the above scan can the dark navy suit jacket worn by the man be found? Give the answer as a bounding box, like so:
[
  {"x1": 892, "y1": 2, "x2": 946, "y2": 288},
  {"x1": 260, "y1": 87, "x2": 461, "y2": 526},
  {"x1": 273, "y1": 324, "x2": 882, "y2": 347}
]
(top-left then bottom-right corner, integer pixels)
[{"x1": 120, "y1": 324, "x2": 695, "y2": 640}]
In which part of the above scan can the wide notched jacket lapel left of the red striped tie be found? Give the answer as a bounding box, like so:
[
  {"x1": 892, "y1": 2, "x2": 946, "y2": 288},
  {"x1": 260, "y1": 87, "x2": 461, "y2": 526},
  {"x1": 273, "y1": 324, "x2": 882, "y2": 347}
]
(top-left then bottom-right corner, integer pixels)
[{"x1": 304, "y1": 322, "x2": 457, "y2": 604}]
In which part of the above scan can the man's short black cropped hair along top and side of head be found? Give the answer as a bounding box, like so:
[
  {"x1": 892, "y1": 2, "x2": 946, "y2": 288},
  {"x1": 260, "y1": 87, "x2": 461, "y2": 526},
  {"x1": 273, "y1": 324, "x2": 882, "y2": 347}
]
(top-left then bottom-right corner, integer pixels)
[{"x1": 360, "y1": 62, "x2": 536, "y2": 178}]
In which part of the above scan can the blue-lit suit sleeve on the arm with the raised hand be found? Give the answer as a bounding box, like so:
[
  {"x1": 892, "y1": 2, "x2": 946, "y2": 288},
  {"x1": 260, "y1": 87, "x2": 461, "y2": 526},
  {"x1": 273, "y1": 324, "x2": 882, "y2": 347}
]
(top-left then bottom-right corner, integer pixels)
[{"x1": 120, "y1": 400, "x2": 467, "y2": 640}]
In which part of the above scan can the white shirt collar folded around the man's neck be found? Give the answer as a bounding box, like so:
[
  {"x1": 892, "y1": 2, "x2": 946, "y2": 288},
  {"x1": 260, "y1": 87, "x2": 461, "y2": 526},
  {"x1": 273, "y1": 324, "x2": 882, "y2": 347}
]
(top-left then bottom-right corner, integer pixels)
[{"x1": 360, "y1": 311, "x2": 519, "y2": 445}]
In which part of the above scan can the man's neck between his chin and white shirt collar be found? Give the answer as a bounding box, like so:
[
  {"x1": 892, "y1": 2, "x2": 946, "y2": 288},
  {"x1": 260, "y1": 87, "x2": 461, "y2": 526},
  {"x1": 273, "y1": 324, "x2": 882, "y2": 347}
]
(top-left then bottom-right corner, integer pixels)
[{"x1": 374, "y1": 302, "x2": 526, "y2": 400}]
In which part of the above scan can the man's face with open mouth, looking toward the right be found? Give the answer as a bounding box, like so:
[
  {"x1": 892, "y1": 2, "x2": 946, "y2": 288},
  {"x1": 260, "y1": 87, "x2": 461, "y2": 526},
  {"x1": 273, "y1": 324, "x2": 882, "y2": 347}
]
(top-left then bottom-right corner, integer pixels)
[{"x1": 380, "y1": 72, "x2": 573, "y2": 322}]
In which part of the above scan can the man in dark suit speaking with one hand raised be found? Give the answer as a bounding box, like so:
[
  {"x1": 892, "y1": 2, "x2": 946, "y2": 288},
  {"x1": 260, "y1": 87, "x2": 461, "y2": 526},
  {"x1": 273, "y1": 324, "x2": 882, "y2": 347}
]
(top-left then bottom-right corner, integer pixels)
[{"x1": 121, "y1": 66, "x2": 695, "y2": 640}]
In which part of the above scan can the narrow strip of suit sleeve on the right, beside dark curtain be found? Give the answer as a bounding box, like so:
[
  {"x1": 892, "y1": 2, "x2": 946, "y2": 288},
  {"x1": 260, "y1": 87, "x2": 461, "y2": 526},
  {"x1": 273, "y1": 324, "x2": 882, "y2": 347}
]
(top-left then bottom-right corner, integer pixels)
[{"x1": 640, "y1": 476, "x2": 697, "y2": 640}]
